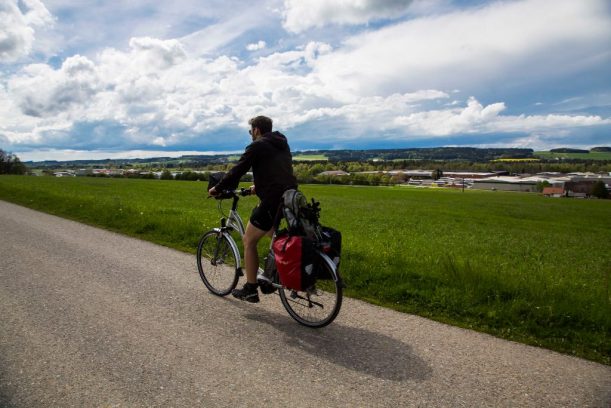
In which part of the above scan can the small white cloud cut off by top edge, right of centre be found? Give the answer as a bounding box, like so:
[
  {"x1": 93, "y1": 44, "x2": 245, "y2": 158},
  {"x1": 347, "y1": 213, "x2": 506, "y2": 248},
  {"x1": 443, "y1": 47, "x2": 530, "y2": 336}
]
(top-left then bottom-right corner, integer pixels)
[{"x1": 283, "y1": 0, "x2": 412, "y2": 33}]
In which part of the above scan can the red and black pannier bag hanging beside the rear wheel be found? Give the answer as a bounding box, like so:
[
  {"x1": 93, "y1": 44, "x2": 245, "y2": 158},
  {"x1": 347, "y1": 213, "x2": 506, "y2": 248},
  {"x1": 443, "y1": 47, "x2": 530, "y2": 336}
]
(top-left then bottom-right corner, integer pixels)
[{"x1": 272, "y1": 234, "x2": 316, "y2": 291}]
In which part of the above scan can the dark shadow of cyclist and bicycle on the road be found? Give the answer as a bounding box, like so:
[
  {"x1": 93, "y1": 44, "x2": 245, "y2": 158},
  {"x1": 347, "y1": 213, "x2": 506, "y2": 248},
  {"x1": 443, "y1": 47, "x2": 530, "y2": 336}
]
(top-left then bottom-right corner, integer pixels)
[{"x1": 245, "y1": 313, "x2": 432, "y2": 381}]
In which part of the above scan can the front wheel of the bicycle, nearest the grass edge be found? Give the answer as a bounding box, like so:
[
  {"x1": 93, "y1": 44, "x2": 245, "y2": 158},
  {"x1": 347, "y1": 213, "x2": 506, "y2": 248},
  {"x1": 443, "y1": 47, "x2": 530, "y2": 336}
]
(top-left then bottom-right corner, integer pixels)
[{"x1": 197, "y1": 230, "x2": 240, "y2": 296}]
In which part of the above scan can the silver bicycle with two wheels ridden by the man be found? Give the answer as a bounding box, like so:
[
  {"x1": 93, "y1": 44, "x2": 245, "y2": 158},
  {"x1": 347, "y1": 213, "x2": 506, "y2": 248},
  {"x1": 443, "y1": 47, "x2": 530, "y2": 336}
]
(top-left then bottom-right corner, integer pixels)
[{"x1": 197, "y1": 189, "x2": 343, "y2": 328}]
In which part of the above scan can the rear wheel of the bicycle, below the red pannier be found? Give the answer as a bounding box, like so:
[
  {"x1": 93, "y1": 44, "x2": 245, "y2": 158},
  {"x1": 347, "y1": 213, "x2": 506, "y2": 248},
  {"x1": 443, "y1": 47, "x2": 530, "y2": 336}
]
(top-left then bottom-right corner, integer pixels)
[{"x1": 279, "y1": 255, "x2": 343, "y2": 328}]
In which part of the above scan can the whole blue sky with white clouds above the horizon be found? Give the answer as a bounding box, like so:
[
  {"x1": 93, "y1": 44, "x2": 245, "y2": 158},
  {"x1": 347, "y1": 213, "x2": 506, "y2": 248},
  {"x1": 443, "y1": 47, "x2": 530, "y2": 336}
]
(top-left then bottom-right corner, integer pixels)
[{"x1": 0, "y1": 0, "x2": 611, "y2": 161}]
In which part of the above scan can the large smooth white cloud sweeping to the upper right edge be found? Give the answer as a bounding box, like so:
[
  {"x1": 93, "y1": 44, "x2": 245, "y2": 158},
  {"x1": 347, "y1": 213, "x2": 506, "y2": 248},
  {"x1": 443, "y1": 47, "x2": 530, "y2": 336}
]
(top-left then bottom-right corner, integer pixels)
[{"x1": 304, "y1": 0, "x2": 611, "y2": 95}]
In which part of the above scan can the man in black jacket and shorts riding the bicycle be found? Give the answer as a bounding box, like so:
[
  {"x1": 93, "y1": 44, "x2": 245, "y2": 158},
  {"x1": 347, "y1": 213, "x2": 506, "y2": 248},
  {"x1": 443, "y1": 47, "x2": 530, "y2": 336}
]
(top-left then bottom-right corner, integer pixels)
[{"x1": 208, "y1": 116, "x2": 297, "y2": 303}]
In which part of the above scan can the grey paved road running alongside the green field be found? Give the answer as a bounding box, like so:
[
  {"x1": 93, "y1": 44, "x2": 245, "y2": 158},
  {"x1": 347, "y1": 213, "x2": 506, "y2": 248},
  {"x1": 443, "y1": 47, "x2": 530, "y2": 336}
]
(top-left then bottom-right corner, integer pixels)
[{"x1": 0, "y1": 201, "x2": 611, "y2": 408}]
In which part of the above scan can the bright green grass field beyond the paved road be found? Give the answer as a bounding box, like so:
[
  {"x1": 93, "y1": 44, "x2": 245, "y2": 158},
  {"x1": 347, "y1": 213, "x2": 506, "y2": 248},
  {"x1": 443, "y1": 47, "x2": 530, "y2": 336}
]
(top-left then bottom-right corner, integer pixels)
[{"x1": 0, "y1": 176, "x2": 611, "y2": 364}]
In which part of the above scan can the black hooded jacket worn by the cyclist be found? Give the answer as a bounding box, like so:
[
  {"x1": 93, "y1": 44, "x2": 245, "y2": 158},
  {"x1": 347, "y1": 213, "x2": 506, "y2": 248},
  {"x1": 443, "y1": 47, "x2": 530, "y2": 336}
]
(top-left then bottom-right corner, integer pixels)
[{"x1": 216, "y1": 132, "x2": 297, "y2": 207}]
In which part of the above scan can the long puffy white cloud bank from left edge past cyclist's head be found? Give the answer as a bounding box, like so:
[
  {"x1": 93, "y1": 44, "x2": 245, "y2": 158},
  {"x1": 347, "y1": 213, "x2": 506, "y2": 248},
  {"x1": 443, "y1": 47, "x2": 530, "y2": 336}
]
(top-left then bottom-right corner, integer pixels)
[{"x1": 0, "y1": 38, "x2": 438, "y2": 146}]
